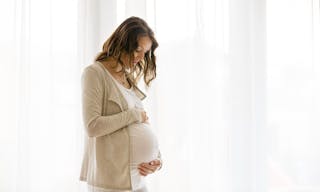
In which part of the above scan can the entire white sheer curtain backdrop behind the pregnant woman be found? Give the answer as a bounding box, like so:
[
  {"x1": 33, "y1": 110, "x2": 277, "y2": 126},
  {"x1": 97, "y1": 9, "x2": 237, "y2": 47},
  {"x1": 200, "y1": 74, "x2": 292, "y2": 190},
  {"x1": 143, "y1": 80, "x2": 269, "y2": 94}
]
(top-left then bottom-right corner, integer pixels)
[{"x1": 0, "y1": 0, "x2": 320, "y2": 192}]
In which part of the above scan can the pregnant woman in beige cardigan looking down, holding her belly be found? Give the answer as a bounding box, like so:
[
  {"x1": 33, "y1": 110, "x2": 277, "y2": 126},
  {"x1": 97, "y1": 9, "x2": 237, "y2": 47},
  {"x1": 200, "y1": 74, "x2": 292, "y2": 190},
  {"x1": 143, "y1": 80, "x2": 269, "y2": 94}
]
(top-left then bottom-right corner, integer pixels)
[{"x1": 80, "y1": 17, "x2": 162, "y2": 192}]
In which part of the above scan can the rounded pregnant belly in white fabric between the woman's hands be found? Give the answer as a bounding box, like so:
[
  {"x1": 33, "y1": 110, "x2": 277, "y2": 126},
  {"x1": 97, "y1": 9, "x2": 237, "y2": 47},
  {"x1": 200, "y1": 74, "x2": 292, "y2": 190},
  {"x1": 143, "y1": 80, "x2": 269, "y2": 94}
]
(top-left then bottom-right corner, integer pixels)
[{"x1": 129, "y1": 123, "x2": 158, "y2": 164}]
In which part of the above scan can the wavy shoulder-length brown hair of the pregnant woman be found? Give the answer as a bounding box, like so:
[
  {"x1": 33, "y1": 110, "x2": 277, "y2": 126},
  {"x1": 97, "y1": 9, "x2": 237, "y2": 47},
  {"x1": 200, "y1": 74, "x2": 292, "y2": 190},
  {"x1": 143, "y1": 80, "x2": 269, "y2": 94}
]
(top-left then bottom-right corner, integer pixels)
[{"x1": 95, "y1": 17, "x2": 158, "y2": 86}]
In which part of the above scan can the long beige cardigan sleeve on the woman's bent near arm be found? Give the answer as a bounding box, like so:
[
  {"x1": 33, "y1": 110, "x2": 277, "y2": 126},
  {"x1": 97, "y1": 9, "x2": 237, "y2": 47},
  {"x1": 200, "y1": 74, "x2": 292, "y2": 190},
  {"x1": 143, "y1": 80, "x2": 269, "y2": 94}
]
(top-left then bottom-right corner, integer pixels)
[{"x1": 81, "y1": 67, "x2": 142, "y2": 137}]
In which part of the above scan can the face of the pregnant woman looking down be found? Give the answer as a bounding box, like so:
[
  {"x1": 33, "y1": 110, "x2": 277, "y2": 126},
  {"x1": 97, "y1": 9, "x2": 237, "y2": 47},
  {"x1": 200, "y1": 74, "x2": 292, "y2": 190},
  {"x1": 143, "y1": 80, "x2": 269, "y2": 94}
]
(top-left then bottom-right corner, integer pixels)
[{"x1": 124, "y1": 36, "x2": 152, "y2": 68}]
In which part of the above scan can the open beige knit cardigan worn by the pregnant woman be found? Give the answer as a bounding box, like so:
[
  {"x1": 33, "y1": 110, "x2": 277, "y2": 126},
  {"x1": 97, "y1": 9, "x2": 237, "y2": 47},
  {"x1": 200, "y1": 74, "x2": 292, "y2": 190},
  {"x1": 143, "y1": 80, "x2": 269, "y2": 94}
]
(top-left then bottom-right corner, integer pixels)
[{"x1": 80, "y1": 62, "x2": 145, "y2": 190}]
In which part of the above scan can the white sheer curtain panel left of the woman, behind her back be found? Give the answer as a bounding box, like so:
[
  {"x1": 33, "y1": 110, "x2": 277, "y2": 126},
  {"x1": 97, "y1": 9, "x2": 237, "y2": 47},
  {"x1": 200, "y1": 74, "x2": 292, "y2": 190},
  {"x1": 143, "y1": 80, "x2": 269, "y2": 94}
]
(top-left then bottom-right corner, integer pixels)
[{"x1": 0, "y1": 0, "x2": 82, "y2": 192}]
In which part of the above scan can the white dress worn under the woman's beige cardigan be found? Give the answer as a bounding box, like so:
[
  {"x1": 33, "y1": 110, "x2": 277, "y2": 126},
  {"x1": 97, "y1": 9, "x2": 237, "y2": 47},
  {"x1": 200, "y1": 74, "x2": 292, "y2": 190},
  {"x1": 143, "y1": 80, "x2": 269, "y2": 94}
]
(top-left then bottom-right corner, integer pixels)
[{"x1": 89, "y1": 70, "x2": 159, "y2": 192}]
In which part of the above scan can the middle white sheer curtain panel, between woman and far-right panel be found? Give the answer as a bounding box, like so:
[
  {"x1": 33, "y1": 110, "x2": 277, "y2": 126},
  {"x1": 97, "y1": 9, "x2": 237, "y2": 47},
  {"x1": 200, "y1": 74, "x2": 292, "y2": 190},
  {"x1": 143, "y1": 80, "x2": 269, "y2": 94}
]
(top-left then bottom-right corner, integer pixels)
[{"x1": 152, "y1": 0, "x2": 267, "y2": 192}]
